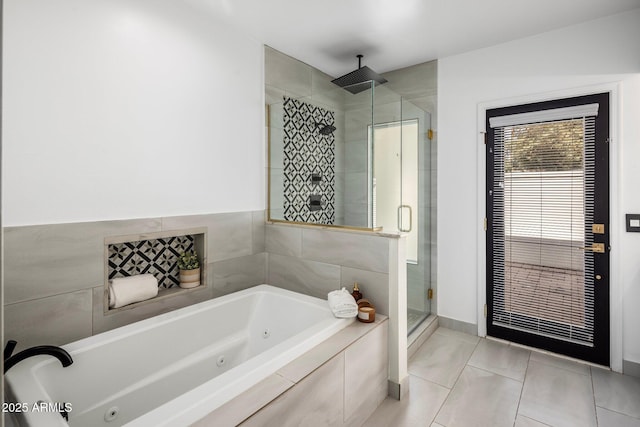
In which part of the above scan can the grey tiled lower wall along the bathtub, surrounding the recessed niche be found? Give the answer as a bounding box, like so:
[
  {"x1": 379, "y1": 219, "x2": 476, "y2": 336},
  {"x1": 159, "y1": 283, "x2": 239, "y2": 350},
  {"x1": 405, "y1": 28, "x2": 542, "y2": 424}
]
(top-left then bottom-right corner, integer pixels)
[{"x1": 3, "y1": 211, "x2": 267, "y2": 349}]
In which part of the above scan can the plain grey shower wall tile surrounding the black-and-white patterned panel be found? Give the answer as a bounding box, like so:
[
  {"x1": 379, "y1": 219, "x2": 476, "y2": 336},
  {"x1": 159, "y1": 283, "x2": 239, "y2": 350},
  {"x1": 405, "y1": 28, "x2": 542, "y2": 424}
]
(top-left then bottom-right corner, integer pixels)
[{"x1": 265, "y1": 47, "x2": 437, "y2": 313}]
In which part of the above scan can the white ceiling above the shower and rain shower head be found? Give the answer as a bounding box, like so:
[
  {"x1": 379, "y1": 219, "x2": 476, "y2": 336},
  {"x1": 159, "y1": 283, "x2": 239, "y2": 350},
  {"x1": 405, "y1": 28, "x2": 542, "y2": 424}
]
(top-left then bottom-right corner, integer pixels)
[{"x1": 183, "y1": 0, "x2": 640, "y2": 77}]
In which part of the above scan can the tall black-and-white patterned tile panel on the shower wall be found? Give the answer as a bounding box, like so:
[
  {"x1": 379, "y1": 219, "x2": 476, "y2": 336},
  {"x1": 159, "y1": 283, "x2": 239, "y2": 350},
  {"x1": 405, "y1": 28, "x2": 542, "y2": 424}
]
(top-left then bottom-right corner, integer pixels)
[{"x1": 283, "y1": 97, "x2": 335, "y2": 224}]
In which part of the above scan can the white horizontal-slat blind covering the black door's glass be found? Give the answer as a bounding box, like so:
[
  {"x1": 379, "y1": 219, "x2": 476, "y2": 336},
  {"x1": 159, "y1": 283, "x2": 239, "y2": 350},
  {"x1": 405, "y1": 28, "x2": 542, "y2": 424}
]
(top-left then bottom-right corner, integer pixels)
[{"x1": 490, "y1": 115, "x2": 597, "y2": 345}]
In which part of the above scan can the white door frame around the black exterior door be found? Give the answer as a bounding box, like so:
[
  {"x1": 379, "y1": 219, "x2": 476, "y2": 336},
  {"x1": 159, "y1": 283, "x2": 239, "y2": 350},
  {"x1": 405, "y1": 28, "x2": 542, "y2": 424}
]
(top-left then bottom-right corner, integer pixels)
[{"x1": 476, "y1": 83, "x2": 623, "y2": 372}]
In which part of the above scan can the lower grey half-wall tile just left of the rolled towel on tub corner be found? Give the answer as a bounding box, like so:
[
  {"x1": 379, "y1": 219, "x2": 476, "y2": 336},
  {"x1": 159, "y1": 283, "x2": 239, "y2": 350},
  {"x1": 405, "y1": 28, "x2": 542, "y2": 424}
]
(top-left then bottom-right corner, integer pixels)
[{"x1": 268, "y1": 254, "x2": 340, "y2": 299}]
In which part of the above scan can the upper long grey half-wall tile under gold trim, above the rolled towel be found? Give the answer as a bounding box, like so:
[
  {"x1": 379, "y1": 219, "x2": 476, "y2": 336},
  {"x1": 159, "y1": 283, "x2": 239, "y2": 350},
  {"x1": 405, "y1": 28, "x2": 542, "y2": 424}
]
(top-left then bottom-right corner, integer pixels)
[{"x1": 302, "y1": 229, "x2": 389, "y2": 273}]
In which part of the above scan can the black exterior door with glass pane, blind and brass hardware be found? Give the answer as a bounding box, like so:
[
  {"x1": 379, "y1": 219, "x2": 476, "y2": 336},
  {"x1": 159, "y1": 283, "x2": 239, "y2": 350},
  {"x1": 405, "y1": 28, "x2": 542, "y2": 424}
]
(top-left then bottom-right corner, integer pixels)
[{"x1": 486, "y1": 93, "x2": 610, "y2": 366}]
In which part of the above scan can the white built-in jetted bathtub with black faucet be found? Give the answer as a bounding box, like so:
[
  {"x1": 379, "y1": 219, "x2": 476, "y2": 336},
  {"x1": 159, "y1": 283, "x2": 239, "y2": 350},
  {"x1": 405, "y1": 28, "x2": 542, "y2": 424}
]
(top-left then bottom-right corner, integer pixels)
[{"x1": 6, "y1": 285, "x2": 353, "y2": 427}]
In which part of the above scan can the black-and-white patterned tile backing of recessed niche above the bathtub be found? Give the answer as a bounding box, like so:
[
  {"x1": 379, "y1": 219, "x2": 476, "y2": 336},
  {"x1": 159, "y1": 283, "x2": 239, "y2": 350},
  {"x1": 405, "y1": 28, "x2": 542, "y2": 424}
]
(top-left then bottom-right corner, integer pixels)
[{"x1": 108, "y1": 236, "x2": 195, "y2": 288}]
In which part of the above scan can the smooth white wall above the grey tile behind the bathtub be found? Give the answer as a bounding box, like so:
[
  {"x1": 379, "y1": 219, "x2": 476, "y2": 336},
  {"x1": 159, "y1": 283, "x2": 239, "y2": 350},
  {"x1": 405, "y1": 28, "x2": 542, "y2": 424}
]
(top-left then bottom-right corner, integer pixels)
[{"x1": 2, "y1": 0, "x2": 265, "y2": 226}]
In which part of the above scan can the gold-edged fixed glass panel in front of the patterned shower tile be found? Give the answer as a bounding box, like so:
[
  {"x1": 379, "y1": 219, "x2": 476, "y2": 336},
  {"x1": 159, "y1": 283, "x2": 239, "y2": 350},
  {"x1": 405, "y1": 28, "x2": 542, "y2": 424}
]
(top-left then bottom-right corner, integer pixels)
[{"x1": 267, "y1": 83, "x2": 374, "y2": 228}]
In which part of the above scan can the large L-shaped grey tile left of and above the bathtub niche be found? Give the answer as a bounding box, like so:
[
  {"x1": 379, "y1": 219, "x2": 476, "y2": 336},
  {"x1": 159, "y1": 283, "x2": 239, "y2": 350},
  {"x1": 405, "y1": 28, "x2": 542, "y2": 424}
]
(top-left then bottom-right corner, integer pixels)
[{"x1": 4, "y1": 219, "x2": 160, "y2": 303}]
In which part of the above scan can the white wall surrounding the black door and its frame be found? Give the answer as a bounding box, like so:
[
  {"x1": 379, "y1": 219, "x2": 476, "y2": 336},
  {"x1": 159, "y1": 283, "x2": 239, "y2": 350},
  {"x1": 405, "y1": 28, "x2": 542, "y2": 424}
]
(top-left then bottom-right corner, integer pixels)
[{"x1": 438, "y1": 9, "x2": 640, "y2": 363}]
